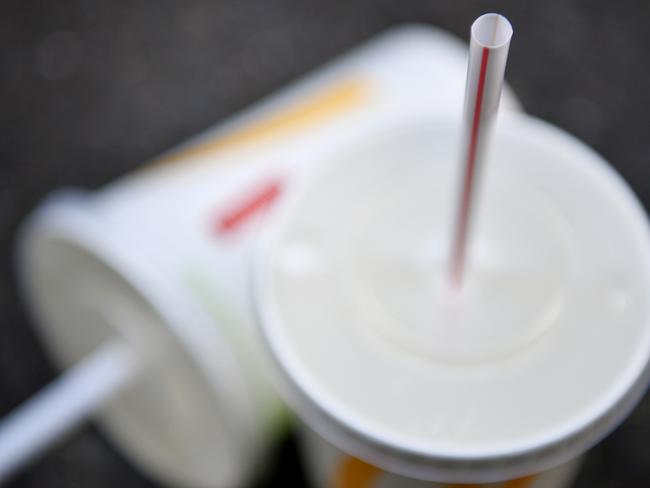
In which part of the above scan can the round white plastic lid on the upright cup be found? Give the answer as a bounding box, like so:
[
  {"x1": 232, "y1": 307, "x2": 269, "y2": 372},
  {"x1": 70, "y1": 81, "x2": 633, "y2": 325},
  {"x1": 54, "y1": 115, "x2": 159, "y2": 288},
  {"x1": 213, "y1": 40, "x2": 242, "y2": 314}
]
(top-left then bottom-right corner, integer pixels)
[{"x1": 253, "y1": 115, "x2": 650, "y2": 488}]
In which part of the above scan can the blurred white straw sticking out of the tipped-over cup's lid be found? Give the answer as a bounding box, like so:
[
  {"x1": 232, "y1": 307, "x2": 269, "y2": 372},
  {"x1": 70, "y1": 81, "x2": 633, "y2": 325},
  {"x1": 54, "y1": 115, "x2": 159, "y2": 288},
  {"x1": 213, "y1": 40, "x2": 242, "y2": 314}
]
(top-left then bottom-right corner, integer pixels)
[{"x1": 0, "y1": 342, "x2": 139, "y2": 483}]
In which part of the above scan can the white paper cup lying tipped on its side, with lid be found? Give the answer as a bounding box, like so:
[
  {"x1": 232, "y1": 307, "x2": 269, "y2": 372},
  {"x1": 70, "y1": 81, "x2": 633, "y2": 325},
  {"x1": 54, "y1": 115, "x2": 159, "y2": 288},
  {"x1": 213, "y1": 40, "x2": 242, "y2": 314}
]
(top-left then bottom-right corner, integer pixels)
[{"x1": 12, "y1": 25, "x2": 519, "y2": 487}]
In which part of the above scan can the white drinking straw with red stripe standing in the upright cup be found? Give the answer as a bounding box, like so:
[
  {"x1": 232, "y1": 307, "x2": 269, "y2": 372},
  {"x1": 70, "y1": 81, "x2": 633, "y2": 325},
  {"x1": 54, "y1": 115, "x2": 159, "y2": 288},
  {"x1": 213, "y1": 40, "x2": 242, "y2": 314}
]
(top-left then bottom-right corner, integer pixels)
[{"x1": 449, "y1": 14, "x2": 512, "y2": 290}]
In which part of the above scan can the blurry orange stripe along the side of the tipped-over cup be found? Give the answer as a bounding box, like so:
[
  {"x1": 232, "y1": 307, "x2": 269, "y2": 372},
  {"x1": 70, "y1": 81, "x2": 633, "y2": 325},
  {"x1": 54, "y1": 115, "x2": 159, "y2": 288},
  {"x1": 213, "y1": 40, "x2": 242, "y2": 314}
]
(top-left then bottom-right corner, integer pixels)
[{"x1": 154, "y1": 79, "x2": 369, "y2": 164}]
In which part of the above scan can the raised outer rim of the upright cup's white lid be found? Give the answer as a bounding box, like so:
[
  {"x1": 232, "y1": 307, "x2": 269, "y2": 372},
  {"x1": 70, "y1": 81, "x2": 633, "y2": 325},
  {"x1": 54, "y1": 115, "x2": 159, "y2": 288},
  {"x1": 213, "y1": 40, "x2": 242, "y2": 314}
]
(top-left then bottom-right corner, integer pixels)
[{"x1": 251, "y1": 113, "x2": 650, "y2": 482}]
